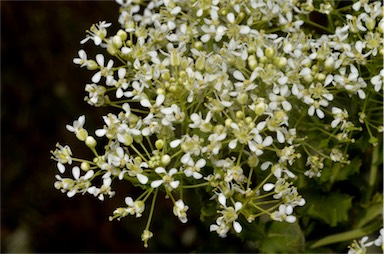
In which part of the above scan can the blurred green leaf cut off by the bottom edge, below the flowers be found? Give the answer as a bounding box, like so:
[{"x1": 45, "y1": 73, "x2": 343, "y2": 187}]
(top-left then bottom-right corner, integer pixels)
[{"x1": 260, "y1": 221, "x2": 304, "y2": 253}]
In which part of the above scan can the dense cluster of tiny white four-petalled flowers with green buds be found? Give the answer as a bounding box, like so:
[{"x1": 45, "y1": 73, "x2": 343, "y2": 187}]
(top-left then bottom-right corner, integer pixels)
[{"x1": 53, "y1": 0, "x2": 384, "y2": 248}]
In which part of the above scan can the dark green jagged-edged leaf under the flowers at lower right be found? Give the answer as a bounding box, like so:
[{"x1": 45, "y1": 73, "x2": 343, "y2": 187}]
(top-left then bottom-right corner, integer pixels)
[{"x1": 306, "y1": 193, "x2": 352, "y2": 227}]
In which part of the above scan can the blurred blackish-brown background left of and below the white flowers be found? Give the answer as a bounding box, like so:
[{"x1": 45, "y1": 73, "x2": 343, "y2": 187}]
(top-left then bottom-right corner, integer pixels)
[{"x1": 0, "y1": 1, "x2": 249, "y2": 253}]
